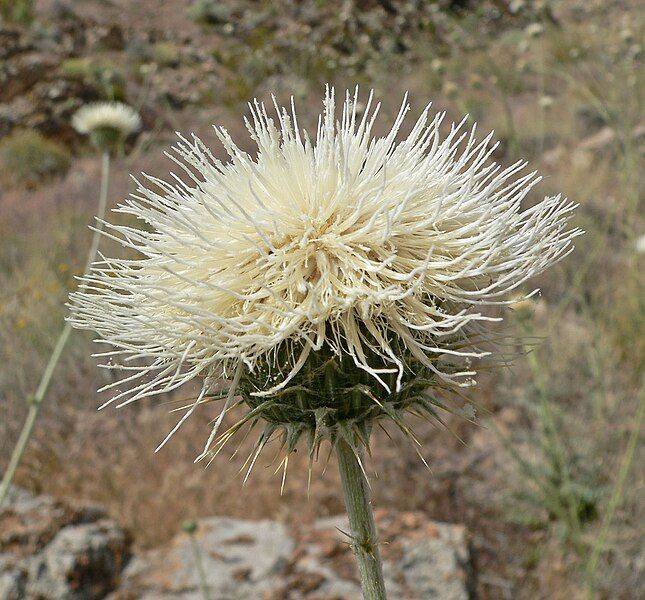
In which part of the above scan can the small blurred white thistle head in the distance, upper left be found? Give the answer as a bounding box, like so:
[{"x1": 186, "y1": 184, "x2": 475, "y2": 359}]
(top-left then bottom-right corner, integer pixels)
[{"x1": 72, "y1": 102, "x2": 141, "y2": 149}]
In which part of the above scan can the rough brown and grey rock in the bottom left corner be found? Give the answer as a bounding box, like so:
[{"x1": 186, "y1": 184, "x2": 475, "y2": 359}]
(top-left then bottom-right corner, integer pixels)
[{"x1": 0, "y1": 488, "x2": 130, "y2": 600}]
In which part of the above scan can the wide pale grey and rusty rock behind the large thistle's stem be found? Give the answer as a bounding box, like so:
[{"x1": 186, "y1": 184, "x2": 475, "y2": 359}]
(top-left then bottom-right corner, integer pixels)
[{"x1": 119, "y1": 511, "x2": 470, "y2": 600}]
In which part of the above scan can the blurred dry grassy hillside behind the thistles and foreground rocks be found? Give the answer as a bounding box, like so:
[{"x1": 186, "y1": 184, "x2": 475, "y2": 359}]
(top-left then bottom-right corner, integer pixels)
[{"x1": 0, "y1": 0, "x2": 645, "y2": 599}]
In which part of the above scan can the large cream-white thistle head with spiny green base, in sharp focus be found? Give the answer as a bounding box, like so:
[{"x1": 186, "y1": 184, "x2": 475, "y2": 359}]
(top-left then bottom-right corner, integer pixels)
[{"x1": 71, "y1": 90, "x2": 579, "y2": 466}]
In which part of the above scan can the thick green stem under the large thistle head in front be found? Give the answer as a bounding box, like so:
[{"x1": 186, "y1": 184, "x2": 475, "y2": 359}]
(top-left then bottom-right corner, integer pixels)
[{"x1": 336, "y1": 439, "x2": 386, "y2": 600}]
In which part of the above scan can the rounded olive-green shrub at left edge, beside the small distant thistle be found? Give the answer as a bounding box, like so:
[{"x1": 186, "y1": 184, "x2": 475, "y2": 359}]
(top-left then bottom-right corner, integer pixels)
[{"x1": 0, "y1": 130, "x2": 70, "y2": 187}]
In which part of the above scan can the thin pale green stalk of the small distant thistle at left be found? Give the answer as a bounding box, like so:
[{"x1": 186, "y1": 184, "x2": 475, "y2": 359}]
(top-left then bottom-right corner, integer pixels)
[{"x1": 0, "y1": 152, "x2": 110, "y2": 506}]
